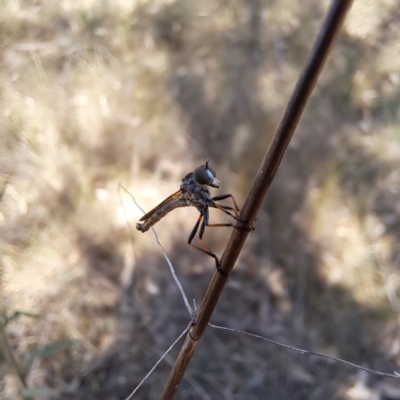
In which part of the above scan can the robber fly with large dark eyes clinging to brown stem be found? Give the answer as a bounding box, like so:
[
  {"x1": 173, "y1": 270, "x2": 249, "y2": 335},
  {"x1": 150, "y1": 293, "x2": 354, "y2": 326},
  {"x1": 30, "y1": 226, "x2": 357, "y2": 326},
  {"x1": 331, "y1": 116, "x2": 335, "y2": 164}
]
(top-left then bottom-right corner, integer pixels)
[{"x1": 136, "y1": 161, "x2": 240, "y2": 270}]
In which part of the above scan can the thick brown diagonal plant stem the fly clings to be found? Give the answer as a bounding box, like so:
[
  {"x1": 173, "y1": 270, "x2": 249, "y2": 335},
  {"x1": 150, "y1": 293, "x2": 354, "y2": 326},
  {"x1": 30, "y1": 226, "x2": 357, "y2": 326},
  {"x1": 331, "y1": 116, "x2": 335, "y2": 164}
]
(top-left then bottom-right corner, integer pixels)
[{"x1": 160, "y1": 0, "x2": 352, "y2": 400}]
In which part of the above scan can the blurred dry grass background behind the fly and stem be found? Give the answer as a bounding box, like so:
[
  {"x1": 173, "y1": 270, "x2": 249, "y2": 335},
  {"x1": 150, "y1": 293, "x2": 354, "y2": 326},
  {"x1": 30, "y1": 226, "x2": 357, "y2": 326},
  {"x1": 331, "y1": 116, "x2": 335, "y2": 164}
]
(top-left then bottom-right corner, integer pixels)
[{"x1": 0, "y1": 0, "x2": 400, "y2": 400}]
